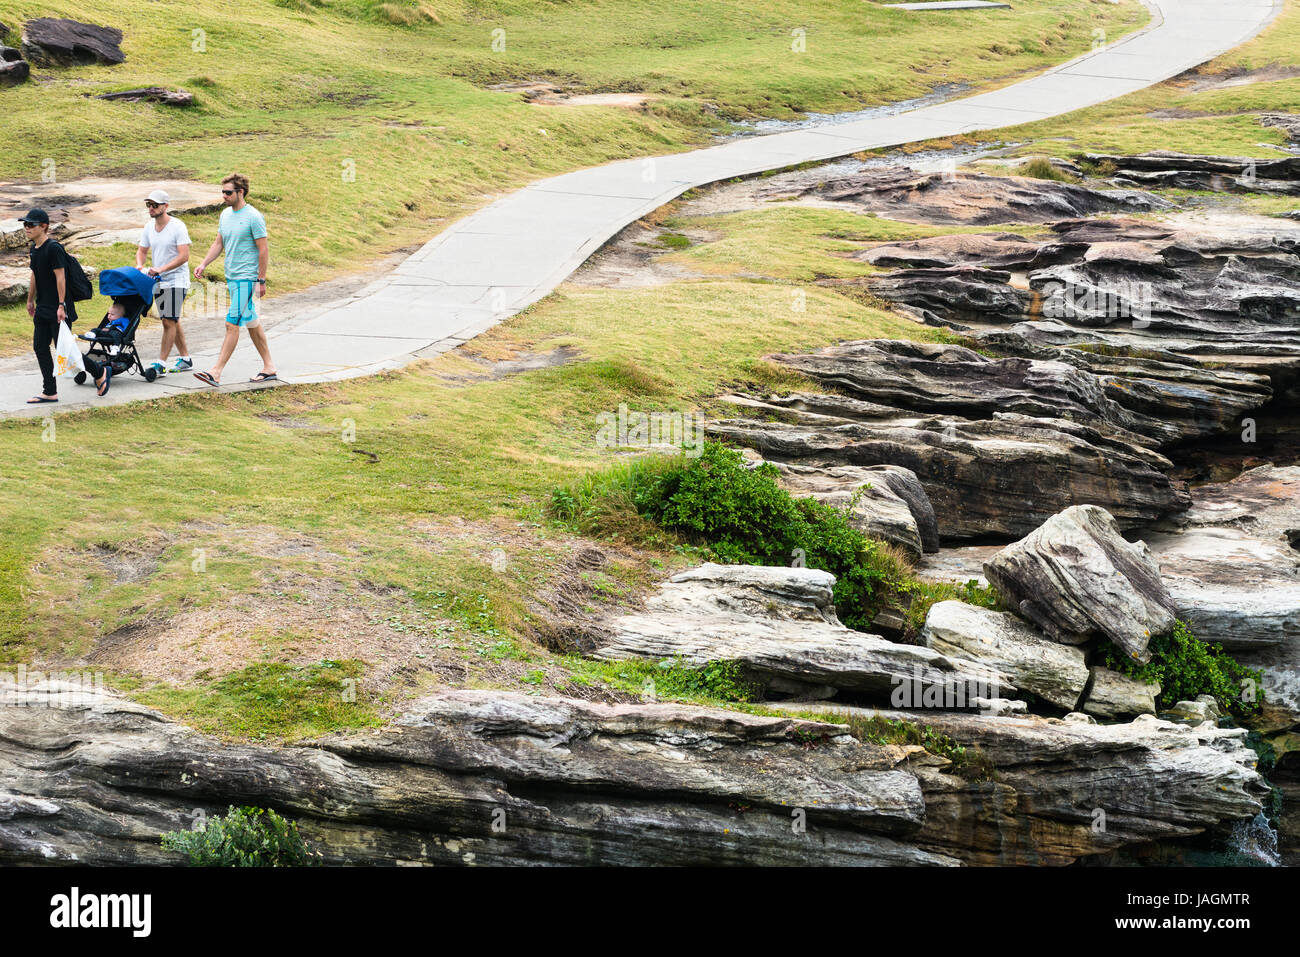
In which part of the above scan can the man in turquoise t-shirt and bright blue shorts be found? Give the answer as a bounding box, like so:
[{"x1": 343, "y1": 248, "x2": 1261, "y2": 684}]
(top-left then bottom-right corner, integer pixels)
[{"x1": 194, "y1": 173, "x2": 276, "y2": 385}]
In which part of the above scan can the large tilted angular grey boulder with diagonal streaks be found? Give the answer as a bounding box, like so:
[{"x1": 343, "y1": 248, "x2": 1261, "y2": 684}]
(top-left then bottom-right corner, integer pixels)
[{"x1": 984, "y1": 506, "x2": 1178, "y2": 662}]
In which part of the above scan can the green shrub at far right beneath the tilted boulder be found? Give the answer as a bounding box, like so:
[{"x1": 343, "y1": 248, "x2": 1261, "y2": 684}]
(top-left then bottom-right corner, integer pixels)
[{"x1": 1102, "y1": 622, "x2": 1264, "y2": 718}]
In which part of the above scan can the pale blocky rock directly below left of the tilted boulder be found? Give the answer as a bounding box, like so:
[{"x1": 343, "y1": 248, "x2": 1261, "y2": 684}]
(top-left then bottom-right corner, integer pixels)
[{"x1": 920, "y1": 601, "x2": 1088, "y2": 711}]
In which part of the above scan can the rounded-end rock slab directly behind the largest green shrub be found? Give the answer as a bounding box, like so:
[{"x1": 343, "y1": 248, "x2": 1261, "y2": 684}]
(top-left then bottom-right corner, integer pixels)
[{"x1": 772, "y1": 463, "x2": 939, "y2": 560}]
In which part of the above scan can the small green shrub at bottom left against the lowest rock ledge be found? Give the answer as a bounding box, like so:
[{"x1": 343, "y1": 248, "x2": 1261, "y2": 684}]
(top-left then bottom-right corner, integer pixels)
[{"x1": 163, "y1": 807, "x2": 312, "y2": 867}]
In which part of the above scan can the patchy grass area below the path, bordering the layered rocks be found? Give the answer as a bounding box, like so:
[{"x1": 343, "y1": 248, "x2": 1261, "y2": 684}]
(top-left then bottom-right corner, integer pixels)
[{"x1": 0, "y1": 209, "x2": 930, "y2": 737}]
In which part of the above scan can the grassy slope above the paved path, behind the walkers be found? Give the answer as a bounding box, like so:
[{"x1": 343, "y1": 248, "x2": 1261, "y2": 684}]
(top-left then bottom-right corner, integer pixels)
[{"x1": 0, "y1": 0, "x2": 1145, "y2": 354}]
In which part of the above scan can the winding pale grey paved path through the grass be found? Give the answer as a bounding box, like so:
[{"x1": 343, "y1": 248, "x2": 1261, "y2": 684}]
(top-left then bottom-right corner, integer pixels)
[{"x1": 0, "y1": 0, "x2": 1282, "y2": 416}]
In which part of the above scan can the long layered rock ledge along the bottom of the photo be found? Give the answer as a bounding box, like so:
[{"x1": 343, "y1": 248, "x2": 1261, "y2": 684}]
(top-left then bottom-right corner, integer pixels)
[{"x1": 0, "y1": 685, "x2": 1262, "y2": 865}]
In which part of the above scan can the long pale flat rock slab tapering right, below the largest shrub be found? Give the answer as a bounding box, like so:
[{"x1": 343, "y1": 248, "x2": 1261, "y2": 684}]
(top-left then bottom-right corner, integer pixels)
[{"x1": 592, "y1": 563, "x2": 1015, "y2": 707}]
